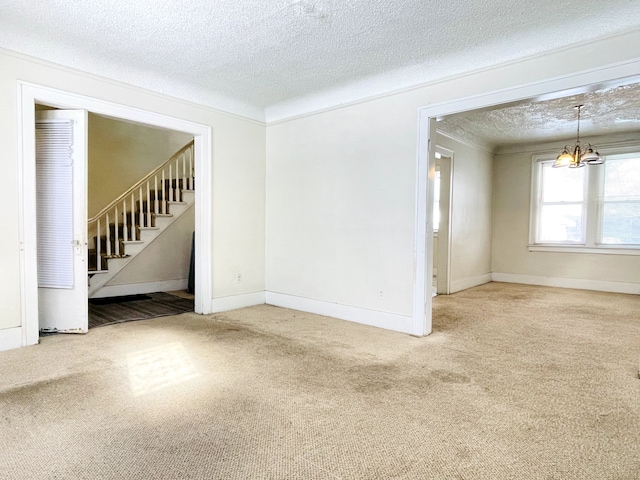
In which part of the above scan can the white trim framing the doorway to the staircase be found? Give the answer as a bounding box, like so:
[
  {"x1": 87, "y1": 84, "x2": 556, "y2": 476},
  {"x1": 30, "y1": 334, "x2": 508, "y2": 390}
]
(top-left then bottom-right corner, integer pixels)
[{"x1": 18, "y1": 81, "x2": 213, "y2": 346}]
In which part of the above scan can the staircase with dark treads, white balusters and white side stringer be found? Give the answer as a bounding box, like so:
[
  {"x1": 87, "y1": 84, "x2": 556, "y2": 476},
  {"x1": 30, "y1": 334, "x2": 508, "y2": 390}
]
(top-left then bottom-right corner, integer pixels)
[{"x1": 87, "y1": 142, "x2": 195, "y2": 298}]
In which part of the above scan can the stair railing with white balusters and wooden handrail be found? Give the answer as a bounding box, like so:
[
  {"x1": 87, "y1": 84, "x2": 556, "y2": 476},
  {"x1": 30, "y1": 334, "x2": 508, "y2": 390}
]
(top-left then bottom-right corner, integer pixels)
[{"x1": 87, "y1": 141, "x2": 194, "y2": 271}]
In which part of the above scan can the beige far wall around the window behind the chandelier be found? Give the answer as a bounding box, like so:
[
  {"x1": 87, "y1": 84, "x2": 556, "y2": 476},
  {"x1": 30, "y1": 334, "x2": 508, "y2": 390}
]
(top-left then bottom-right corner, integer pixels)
[{"x1": 492, "y1": 134, "x2": 640, "y2": 293}]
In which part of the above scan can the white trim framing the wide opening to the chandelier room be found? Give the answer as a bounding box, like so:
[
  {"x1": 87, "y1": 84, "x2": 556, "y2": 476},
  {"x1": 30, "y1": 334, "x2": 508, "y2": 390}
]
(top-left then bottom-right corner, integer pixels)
[{"x1": 411, "y1": 60, "x2": 640, "y2": 336}]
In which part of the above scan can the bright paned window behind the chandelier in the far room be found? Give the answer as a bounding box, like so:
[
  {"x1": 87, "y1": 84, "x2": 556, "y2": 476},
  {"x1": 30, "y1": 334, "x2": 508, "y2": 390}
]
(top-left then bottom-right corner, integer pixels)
[{"x1": 530, "y1": 153, "x2": 640, "y2": 254}]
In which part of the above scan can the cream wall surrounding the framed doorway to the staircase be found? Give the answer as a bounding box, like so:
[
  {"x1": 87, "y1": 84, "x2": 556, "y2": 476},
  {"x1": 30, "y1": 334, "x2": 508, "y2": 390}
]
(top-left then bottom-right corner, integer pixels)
[{"x1": 0, "y1": 50, "x2": 265, "y2": 342}]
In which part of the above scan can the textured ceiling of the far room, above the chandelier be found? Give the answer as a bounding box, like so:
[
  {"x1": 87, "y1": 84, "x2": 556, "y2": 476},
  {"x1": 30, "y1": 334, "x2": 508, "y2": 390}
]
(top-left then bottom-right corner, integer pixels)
[{"x1": 438, "y1": 83, "x2": 640, "y2": 150}]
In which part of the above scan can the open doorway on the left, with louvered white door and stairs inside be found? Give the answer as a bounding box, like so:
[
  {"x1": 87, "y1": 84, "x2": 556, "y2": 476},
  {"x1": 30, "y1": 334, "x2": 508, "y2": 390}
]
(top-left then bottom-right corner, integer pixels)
[{"x1": 36, "y1": 108, "x2": 194, "y2": 335}]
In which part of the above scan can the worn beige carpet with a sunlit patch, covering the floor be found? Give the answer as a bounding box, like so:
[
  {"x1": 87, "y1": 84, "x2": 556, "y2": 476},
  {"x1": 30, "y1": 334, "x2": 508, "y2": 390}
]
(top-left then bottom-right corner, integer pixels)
[{"x1": 0, "y1": 283, "x2": 640, "y2": 480}]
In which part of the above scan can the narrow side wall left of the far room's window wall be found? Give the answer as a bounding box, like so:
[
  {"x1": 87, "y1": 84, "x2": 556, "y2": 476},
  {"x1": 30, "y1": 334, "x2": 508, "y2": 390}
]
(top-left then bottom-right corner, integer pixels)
[{"x1": 437, "y1": 135, "x2": 493, "y2": 293}]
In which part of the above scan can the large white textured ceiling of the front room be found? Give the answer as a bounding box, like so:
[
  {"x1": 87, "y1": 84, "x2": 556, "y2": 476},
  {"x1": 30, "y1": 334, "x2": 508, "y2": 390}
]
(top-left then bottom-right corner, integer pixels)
[{"x1": 0, "y1": 0, "x2": 640, "y2": 122}]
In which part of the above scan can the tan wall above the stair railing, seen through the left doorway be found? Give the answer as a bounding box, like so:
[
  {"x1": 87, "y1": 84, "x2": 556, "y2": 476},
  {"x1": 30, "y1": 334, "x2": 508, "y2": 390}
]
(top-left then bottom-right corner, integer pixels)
[{"x1": 88, "y1": 113, "x2": 193, "y2": 218}]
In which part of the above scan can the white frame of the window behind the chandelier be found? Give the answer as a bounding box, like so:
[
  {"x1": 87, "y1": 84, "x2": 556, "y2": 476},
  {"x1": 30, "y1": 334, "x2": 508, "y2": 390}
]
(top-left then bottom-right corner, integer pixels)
[{"x1": 528, "y1": 145, "x2": 640, "y2": 255}]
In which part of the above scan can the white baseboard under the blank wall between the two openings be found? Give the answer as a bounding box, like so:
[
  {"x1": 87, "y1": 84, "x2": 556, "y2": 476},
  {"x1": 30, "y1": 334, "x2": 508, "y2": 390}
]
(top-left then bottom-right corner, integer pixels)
[{"x1": 265, "y1": 292, "x2": 412, "y2": 334}]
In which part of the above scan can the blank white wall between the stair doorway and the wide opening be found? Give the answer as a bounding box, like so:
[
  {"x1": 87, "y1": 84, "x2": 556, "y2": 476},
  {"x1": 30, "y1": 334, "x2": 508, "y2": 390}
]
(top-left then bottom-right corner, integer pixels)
[{"x1": 266, "y1": 94, "x2": 416, "y2": 322}]
